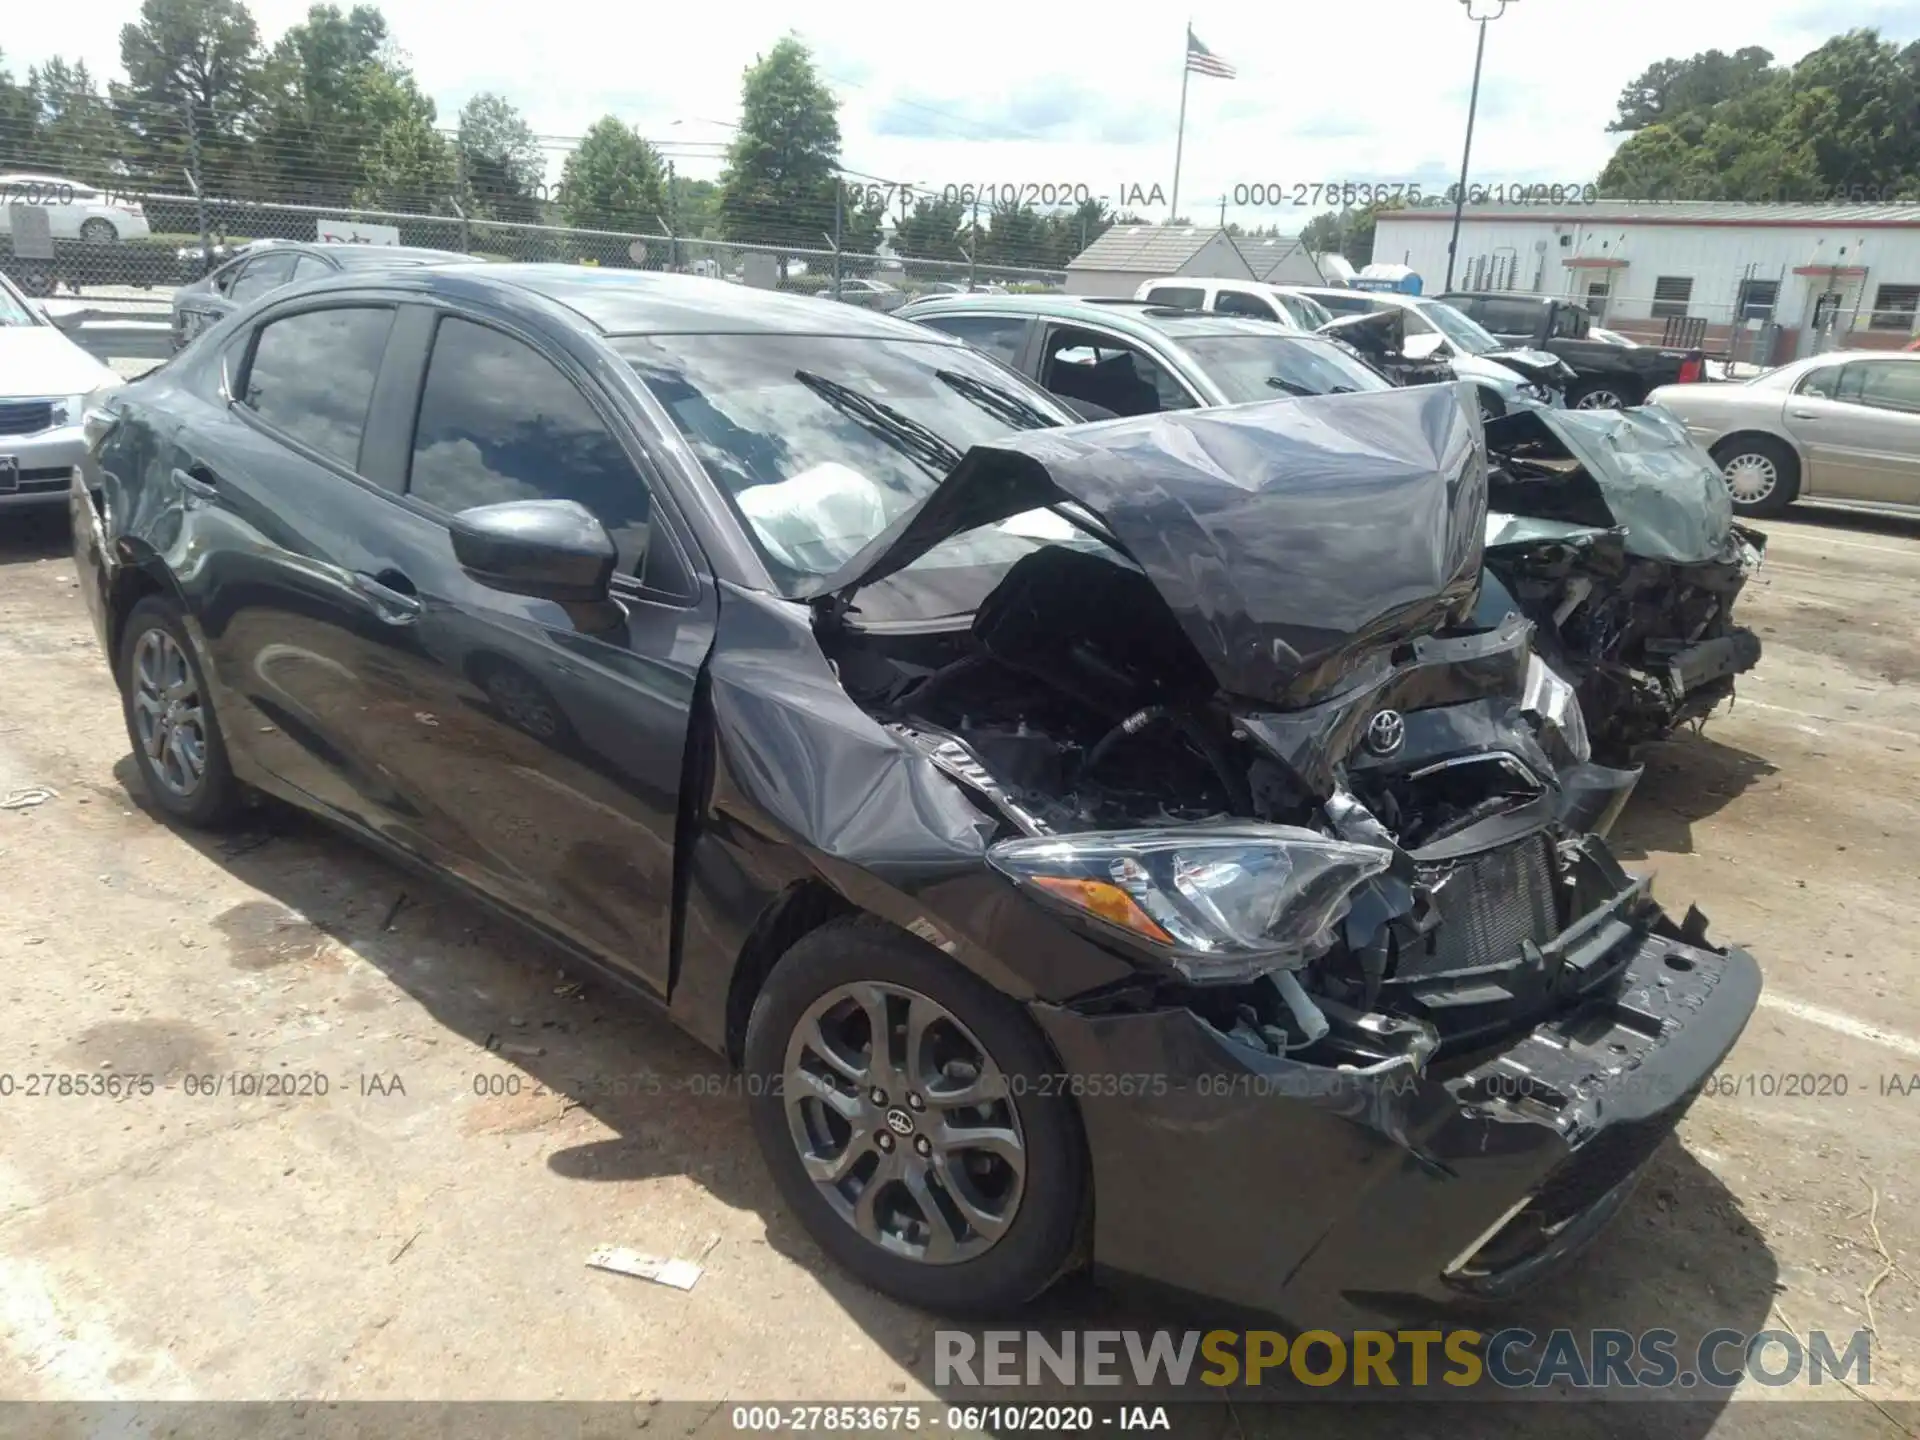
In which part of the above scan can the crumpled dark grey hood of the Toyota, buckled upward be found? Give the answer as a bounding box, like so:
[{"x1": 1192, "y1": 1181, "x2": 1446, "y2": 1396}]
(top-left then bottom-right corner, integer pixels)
[{"x1": 814, "y1": 384, "x2": 1486, "y2": 703}]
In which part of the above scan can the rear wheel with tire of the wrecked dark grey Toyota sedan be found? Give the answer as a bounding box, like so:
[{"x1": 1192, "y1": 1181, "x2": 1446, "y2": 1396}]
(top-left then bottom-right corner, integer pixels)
[{"x1": 119, "y1": 595, "x2": 244, "y2": 828}]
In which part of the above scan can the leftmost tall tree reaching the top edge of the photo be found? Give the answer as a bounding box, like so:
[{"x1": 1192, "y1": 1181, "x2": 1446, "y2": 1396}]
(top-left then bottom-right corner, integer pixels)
[{"x1": 108, "y1": 0, "x2": 261, "y2": 194}]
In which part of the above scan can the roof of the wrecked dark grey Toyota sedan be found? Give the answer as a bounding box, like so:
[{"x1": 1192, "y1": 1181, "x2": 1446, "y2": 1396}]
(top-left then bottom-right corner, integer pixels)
[{"x1": 301, "y1": 261, "x2": 983, "y2": 346}]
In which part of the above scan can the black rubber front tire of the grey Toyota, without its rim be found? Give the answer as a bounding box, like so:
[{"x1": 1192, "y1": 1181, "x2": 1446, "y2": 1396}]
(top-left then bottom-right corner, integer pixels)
[{"x1": 745, "y1": 916, "x2": 1091, "y2": 1315}]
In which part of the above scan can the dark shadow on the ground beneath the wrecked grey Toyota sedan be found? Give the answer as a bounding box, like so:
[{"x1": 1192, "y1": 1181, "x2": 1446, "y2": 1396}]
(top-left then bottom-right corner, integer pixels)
[{"x1": 113, "y1": 747, "x2": 1776, "y2": 1440}]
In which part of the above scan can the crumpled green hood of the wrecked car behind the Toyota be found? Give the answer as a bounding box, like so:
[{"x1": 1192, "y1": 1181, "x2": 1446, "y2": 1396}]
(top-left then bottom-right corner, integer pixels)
[{"x1": 1486, "y1": 405, "x2": 1741, "y2": 564}]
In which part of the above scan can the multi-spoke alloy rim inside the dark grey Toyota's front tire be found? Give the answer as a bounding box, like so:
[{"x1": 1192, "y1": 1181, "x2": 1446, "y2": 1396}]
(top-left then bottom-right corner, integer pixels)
[{"x1": 781, "y1": 981, "x2": 1027, "y2": 1265}]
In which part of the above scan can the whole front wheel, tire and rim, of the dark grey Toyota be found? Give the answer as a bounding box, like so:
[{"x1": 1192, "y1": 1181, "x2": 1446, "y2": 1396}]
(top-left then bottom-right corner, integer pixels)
[{"x1": 745, "y1": 916, "x2": 1089, "y2": 1313}]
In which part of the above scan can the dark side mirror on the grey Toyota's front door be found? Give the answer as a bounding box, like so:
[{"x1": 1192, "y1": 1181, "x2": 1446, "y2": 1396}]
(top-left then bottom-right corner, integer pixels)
[{"x1": 449, "y1": 499, "x2": 618, "y2": 605}]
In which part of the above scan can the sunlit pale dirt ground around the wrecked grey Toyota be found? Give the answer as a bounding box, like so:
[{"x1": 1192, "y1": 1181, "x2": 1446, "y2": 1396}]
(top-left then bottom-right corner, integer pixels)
[{"x1": 0, "y1": 511, "x2": 1920, "y2": 1436}]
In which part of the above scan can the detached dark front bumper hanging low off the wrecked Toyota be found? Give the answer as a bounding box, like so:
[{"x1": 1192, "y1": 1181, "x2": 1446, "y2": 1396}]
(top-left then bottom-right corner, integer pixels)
[{"x1": 1033, "y1": 931, "x2": 1761, "y2": 1327}]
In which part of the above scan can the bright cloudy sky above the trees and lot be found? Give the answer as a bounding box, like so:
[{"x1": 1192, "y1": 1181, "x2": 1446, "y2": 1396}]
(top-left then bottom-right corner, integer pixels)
[{"x1": 0, "y1": 0, "x2": 1920, "y2": 225}]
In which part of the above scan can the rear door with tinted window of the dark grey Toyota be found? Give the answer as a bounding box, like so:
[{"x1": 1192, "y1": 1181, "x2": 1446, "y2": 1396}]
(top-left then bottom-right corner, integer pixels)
[{"x1": 169, "y1": 296, "x2": 432, "y2": 833}]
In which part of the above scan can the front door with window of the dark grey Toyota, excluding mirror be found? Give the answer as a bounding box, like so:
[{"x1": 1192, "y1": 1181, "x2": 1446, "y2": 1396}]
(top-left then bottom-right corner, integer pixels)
[{"x1": 367, "y1": 315, "x2": 714, "y2": 993}]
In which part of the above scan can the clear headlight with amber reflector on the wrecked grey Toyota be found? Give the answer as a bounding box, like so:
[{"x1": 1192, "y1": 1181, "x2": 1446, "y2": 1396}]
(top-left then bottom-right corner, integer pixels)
[{"x1": 987, "y1": 824, "x2": 1394, "y2": 983}]
